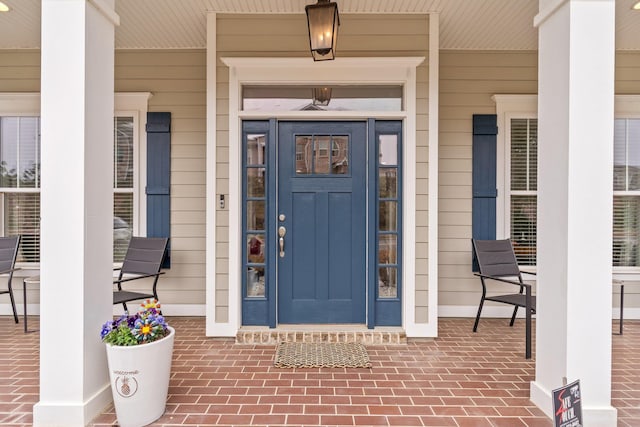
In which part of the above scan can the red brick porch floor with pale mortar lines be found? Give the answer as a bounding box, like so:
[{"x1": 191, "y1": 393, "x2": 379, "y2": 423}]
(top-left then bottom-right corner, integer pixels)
[{"x1": 0, "y1": 316, "x2": 640, "y2": 427}]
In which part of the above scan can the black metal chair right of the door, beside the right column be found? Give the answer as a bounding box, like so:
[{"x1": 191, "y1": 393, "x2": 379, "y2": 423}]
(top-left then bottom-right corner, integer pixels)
[{"x1": 471, "y1": 239, "x2": 536, "y2": 359}]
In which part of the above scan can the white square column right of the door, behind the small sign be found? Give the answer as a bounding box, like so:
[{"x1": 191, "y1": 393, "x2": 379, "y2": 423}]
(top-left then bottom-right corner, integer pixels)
[{"x1": 531, "y1": 0, "x2": 617, "y2": 427}]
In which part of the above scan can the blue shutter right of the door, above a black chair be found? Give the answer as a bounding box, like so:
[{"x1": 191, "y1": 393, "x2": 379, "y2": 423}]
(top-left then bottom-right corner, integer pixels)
[{"x1": 472, "y1": 114, "x2": 498, "y2": 271}]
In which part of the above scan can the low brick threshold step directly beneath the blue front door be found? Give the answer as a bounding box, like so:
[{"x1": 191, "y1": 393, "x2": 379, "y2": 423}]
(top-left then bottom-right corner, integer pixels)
[{"x1": 236, "y1": 324, "x2": 407, "y2": 345}]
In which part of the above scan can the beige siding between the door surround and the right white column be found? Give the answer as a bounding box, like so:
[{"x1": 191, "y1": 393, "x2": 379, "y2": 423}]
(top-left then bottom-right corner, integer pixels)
[{"x1": 438, "y1": 51, "x2": 538, "y2": 312}]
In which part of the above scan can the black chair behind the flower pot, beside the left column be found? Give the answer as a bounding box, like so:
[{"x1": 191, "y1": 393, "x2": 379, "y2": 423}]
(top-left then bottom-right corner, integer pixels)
[{"x1": 113, "y1": 237, "x2": 169, "y2": 311}]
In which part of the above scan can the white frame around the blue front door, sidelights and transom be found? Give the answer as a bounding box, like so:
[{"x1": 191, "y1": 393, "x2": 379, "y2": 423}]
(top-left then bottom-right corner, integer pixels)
[{"x1": 207, "y1": 57, "x2": 428, "y2": 336}]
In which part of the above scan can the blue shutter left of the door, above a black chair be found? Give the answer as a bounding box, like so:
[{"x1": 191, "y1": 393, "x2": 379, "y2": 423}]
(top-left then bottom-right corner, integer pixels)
[{"x1": 146, "y1": 112, "x2": 171, "y2": 268}]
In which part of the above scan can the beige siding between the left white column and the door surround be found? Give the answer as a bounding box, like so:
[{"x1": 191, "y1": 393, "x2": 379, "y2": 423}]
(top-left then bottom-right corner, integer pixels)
[{"x1": 115, "y1": 50, "x2": 206, "y2": 304}]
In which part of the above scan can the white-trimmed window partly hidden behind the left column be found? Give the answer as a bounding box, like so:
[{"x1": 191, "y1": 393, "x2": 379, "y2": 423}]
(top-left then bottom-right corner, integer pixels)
[{"x1": 0, "y1": 93, "x2": 149, "y2": 263}]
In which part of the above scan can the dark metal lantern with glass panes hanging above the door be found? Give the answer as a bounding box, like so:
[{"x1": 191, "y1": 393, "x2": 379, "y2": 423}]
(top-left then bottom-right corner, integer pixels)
[{"x1": 304, "y1": 0, "x2": 340, "y2": 61}]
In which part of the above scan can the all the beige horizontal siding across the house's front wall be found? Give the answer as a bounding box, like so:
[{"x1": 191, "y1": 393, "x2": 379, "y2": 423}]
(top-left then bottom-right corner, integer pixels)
[{"x1": 0, "y1": 45, "x2": 640, "y2": 319}]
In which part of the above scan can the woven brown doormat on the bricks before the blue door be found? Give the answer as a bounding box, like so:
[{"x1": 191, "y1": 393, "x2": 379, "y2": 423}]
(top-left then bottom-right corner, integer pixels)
[{"x1": 274, "y1": 342, "x2": 371, "y2": 368}]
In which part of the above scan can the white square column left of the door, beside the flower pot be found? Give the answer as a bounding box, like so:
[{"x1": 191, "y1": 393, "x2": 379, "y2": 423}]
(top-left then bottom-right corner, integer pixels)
[{"x1": 33, "y1": 0, "x2": 118, "y2": 426}]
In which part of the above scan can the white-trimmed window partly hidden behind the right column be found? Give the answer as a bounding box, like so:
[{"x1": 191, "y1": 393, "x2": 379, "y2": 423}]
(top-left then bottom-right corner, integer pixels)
[{"x1": 494, "y1": 95, "x2": 640, "y2": 271}]
